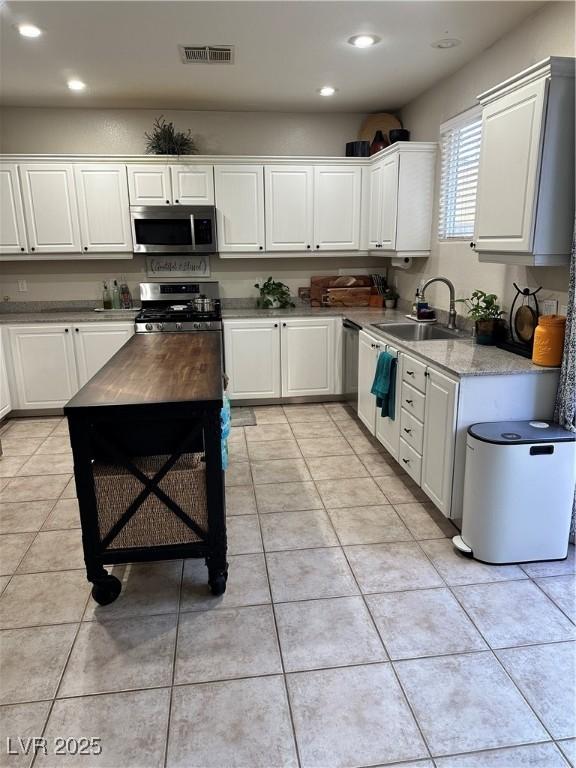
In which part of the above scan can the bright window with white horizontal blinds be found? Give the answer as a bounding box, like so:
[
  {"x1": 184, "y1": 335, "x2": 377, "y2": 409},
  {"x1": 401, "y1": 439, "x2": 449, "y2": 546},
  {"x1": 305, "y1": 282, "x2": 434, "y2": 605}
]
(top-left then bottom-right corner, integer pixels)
[{"x1": 438, "y1": 108, "x2": 482, "y2": 240}]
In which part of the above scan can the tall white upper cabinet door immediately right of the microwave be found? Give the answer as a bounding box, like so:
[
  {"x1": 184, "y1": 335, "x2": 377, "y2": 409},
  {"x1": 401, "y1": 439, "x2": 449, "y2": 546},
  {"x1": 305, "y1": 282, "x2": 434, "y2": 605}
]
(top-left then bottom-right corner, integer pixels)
[{"x1": 214, "y1": 165, "x2": 265, "y2": 253}]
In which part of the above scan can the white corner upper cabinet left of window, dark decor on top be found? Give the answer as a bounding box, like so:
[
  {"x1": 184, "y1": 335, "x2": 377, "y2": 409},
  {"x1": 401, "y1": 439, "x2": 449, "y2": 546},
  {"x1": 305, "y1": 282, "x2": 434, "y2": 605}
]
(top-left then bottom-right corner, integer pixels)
[{"x1": 362, "y1": 142, "x2": 436, "y2": 257}]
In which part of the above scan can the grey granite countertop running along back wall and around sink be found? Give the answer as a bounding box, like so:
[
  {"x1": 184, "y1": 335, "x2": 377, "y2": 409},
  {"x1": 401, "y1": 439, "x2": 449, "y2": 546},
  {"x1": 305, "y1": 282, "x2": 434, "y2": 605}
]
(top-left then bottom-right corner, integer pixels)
[{"x1": 0, "y1": 305, "x2": 558, "y2": 377}]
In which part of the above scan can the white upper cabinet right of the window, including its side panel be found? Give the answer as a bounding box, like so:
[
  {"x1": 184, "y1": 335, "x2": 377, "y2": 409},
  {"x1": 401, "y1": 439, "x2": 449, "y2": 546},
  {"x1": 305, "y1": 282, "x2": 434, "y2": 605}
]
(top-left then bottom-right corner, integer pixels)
[{"x1": 475, "y1": 58, "x2": 574, "y2": 266}]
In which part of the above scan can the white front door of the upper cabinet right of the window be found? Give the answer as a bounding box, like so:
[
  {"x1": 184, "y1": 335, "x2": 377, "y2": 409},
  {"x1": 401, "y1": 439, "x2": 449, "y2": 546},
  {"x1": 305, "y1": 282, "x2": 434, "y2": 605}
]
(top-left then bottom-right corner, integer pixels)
[{"x1": 475, "y1": 78, "x2": 548, "y2": 252}]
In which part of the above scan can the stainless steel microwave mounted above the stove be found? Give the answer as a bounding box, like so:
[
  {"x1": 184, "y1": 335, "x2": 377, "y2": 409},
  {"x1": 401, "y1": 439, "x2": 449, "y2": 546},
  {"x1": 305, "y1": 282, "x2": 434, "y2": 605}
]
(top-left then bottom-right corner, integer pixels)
[{"x1": 130, "y1": 205, "x2": 218, "y2": 253}]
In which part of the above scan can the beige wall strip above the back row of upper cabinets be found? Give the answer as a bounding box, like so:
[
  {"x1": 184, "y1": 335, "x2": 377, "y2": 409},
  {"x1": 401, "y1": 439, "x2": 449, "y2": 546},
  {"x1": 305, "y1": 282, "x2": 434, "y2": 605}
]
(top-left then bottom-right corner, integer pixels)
[{"x1": 0, "y1": 107, "x2": 364, "y2": 156}]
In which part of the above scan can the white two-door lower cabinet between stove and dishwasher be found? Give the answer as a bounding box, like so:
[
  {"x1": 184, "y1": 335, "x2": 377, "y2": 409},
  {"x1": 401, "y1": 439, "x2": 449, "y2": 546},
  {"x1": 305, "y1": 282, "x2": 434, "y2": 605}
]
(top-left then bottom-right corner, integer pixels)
[{"x1": 224, "y1": 318, "x2": 341, "y2": 400}]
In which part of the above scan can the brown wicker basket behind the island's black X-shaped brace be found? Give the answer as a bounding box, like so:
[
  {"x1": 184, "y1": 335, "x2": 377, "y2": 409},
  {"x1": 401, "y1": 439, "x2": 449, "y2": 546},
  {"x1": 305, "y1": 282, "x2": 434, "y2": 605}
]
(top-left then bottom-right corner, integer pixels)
[{"x1": 93, "y1": 453, "x2": 208, "y2": 549}]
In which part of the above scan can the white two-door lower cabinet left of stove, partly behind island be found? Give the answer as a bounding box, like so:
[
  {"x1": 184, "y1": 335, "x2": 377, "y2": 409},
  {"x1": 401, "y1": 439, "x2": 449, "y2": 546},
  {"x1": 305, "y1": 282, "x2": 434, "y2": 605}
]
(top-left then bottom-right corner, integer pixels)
[{"x1": 7, "y1": 322, "x2": 134, "y2": 410}]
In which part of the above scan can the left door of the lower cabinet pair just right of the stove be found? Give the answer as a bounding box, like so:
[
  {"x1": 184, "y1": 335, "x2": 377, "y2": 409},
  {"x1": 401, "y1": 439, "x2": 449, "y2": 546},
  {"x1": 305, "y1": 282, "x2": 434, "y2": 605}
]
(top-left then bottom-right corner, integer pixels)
[{"x1": 224, "y1": 320, "x2": 280, "y2": 400}]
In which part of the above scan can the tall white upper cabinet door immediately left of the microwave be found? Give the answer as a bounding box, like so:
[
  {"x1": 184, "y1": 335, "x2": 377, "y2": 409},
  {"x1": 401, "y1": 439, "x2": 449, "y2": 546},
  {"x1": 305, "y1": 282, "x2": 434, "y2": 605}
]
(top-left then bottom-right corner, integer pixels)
[{"x1": 74, "y1": 164, "x2": 132, "y2": 253}]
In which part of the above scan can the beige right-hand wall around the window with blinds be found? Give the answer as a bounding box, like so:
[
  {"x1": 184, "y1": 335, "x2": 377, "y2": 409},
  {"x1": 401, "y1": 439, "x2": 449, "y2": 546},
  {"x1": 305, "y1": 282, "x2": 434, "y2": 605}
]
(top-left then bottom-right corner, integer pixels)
[{"x1": 395, "y1": 2, "x2": 575, "y2": 316}]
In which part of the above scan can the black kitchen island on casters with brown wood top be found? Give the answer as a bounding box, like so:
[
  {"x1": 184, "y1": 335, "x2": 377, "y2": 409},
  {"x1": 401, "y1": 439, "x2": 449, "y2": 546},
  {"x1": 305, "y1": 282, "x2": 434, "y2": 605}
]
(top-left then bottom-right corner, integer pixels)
[{"x1": 64, "y1": 331, "x2": 228, "y2": 605}]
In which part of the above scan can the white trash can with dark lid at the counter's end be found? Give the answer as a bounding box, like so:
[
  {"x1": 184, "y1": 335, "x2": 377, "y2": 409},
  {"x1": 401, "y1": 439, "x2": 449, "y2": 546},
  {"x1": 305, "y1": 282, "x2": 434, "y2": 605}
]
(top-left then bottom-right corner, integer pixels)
[{"x1": 452, "y1": 421, "x2": 576, "y2": 564}]
